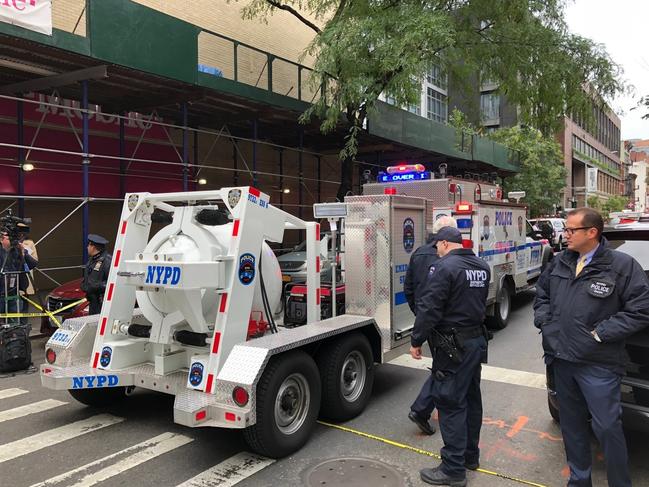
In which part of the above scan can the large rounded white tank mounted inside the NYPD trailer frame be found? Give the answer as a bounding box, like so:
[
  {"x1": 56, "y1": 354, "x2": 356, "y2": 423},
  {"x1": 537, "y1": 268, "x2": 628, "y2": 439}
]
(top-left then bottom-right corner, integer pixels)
[{"x1": 136, "y1": 218, "x2": 282, "y2": 332}]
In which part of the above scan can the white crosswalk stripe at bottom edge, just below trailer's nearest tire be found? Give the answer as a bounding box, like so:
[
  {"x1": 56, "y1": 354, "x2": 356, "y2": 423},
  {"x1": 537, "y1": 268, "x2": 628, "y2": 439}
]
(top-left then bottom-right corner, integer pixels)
[{"x1": 177, "y1": 452, "x2": 275, "y2": 487}]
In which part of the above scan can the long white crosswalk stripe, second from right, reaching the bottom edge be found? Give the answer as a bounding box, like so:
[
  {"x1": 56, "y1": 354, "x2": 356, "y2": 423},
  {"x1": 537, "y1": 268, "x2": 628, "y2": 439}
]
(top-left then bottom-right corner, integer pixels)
[{"x1": 31, "y1": 433, "x2": 194, "y2": 487}]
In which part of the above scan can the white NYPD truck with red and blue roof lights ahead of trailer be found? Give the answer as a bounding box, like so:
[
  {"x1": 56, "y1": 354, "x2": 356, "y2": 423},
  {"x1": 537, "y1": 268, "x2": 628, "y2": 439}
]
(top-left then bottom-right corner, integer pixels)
[{"x1": 364, "y1": 164, "x2": 553, "y2": 329}]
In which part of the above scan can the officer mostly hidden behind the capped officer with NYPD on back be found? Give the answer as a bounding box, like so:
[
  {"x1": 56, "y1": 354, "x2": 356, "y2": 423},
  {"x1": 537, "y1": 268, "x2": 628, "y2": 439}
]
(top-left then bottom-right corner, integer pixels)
[{"x1": 403, "y1": 215, "x2": 457, "y2": 435}]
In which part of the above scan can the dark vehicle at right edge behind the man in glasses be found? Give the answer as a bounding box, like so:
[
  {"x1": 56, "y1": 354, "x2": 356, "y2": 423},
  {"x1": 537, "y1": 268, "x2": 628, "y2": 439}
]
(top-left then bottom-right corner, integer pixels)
[{"x1": 546, "y1": 222, "x2": 649, "y2": 430}]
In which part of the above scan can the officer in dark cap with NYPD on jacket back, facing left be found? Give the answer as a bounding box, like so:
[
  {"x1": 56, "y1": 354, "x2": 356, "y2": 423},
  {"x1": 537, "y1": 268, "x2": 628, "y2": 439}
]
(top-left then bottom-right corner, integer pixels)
[{"x1": 410, "y1": 227, "x2": 491, "y2": 487}]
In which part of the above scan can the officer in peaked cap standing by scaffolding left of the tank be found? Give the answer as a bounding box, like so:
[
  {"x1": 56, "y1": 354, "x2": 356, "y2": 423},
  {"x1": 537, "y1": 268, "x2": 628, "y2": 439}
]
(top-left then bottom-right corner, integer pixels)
[{"x1": 81, "y1": 233, "x2": 113, "y2": 315}]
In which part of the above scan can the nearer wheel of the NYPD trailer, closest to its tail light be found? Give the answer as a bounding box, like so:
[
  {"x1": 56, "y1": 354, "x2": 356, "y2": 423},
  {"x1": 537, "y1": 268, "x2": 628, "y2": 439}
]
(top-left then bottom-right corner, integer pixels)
[{"x1": 243, "y1": 350, "x2": 320, "y2": 458}]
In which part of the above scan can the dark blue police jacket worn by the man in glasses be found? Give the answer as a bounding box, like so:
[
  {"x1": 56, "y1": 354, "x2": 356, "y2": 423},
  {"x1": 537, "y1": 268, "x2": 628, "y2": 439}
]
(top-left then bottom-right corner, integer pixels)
[{"x1": 534, "y1": 237, "x2": 649, "y2": 373}]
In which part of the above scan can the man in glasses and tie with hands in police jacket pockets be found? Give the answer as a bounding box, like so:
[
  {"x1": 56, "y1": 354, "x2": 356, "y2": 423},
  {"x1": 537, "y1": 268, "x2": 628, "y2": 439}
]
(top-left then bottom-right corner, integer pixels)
[{"x1": 534, "y1": 208, "x2": 649, "y2": 487}]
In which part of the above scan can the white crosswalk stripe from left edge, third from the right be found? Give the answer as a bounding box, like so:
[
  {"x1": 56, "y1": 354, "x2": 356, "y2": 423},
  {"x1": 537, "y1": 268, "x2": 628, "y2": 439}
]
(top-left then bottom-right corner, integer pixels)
[{"x1": 0, "y1": 414, "x2": 124, "y2": 463}]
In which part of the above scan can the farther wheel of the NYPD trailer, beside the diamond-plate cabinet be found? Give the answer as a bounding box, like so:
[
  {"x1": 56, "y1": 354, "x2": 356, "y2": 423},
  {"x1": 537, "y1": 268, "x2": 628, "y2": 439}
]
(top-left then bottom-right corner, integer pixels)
[{"x1": 316, "y1": 333, "x2": 374, "y2": 421}]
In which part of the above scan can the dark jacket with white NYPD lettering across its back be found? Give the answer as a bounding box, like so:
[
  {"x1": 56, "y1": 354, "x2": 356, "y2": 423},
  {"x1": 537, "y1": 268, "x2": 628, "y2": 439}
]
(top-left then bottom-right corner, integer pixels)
[{"x1": 410, "y1": 249, "x2": 491, "y2": 347}]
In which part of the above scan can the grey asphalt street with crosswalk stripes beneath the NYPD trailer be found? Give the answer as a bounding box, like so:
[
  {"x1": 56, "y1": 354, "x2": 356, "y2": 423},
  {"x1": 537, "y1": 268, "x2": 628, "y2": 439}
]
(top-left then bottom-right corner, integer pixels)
[{"x1": 0, "y1": 294, "x2": 649, "y2": 487}]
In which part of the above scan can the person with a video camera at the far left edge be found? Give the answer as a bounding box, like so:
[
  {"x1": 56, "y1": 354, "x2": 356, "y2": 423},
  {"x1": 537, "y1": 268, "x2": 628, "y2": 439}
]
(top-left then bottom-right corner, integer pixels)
[{"x1": 0, "y1": 220, "x2": 38, "y2": 327}]
